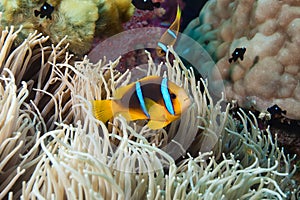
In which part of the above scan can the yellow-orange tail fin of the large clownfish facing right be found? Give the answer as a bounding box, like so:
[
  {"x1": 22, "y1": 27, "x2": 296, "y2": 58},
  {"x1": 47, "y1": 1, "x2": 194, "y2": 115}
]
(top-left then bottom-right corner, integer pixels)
[{"x1": 92, "y1": 100, "x2": 113, "y2": 123}]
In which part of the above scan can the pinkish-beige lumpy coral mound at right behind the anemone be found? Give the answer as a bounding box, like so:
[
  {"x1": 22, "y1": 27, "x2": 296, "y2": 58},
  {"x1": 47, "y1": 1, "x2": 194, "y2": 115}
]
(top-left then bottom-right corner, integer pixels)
[{"x1": 184, "y1": 0, "x2": 300, "y2": 119}]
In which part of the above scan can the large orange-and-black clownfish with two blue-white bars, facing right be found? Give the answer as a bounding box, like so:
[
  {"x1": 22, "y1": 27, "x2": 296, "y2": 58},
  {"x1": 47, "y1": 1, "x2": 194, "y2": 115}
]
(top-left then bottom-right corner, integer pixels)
[{"x1": 92, "y1": 76, "x2": 191, "y2": 130}]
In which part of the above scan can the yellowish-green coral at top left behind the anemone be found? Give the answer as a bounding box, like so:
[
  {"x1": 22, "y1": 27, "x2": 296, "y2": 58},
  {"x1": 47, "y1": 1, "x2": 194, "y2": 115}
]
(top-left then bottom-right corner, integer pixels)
[{"x1": 0, "y1": 0, "x2": 134, "y2": 55}]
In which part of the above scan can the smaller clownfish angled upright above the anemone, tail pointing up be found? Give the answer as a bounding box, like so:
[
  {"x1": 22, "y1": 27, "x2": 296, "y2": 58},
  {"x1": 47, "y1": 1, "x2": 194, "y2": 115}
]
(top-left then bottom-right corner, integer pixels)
[{"x1": 156, "y1": 5, "x2": 181, "y2": 57}]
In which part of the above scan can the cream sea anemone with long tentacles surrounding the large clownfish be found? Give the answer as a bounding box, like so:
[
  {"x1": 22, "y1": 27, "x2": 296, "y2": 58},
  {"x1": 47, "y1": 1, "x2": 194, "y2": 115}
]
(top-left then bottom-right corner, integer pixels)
[{"x1": 0, "y1": 26, "x2": 299, "y2": 199}]
